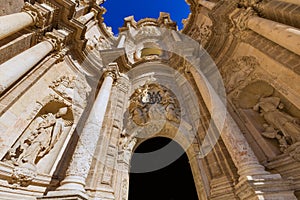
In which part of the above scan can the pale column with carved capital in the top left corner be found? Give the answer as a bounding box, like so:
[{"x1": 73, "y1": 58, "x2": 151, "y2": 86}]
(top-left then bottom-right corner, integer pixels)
[{"x1": 0, "y1": 2, "x2": 46, "y2": 40}]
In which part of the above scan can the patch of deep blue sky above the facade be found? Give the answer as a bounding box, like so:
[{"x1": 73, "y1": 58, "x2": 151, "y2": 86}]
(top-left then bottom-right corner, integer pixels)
[{"x1": 102, "y1": 0, "x2": 190, "y2": 34}]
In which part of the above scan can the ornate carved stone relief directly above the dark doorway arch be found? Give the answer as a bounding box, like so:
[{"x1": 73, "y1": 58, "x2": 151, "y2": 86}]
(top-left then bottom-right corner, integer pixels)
[{"x1": 129, "y1": 83, "x2": 180, "y2": 126}]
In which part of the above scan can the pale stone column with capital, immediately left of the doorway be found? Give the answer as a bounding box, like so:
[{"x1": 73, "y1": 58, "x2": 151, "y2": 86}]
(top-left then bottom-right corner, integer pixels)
[{"x1": 57, "y1": 63, "x2": 118, "y2": 193}]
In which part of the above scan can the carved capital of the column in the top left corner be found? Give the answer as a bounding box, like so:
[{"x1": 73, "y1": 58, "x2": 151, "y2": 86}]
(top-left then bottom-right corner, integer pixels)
[{"x1": 22, "y1": 2, "x2": 47, "y2": 28}]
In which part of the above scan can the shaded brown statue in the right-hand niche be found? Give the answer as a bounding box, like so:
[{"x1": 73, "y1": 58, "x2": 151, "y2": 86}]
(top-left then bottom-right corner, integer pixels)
[{"x1": 253, "y1": 96, "x2": 300, "y2": 145}]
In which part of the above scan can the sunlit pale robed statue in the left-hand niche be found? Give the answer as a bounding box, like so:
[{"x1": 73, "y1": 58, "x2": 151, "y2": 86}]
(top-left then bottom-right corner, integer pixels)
[{"x1": 6, "y1": 107, "x2": 69, "y2": 166}]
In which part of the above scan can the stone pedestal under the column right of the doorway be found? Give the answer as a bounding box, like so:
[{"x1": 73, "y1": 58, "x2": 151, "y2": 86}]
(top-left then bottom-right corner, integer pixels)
[{"x1": 235, "y1": 174, "x2": 297, "y2": 200}]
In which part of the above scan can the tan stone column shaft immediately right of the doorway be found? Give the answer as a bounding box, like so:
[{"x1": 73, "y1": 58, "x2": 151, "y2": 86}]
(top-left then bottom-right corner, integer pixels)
[{"x1": 189, "y1": 67, "x2": 268, "y2": 177}]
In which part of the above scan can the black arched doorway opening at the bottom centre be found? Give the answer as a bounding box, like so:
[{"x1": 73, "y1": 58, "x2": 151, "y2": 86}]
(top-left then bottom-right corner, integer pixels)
[{"x1": 129, "y1": 137, "x2": 198, "y2": 200}]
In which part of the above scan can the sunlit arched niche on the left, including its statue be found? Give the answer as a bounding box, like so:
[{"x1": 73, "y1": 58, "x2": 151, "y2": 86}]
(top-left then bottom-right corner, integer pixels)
[{"x1": 2, "y1": 98, "x2": 74, "y2": 173}]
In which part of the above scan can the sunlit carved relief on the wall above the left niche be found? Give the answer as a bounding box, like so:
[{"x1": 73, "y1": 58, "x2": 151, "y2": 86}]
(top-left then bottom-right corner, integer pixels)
[{"x1": 50, "y1": 76, "x2": 91, "y2": 108}]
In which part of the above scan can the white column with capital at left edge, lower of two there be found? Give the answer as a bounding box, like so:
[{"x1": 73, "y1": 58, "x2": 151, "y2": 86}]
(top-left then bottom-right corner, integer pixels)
[{"x1": 0, "y1": 32, "x2": 62, "y2": 94}]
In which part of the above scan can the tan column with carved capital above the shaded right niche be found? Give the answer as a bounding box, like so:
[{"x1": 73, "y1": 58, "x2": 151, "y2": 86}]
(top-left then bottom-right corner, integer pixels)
[{"x1": 235, "y1": 8, "x2": 300, "y2": 55}]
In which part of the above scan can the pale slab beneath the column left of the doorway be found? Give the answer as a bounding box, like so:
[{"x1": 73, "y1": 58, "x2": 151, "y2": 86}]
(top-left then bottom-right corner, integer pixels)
[{"x1": 36, "y1": 191, "x2": 89, "y2": 200}]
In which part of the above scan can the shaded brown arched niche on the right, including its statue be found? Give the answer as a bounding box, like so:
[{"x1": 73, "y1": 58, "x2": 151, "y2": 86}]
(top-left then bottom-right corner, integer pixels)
[{"x1": 233, "y1": 81, "x2": 300, "y2": 161}]
